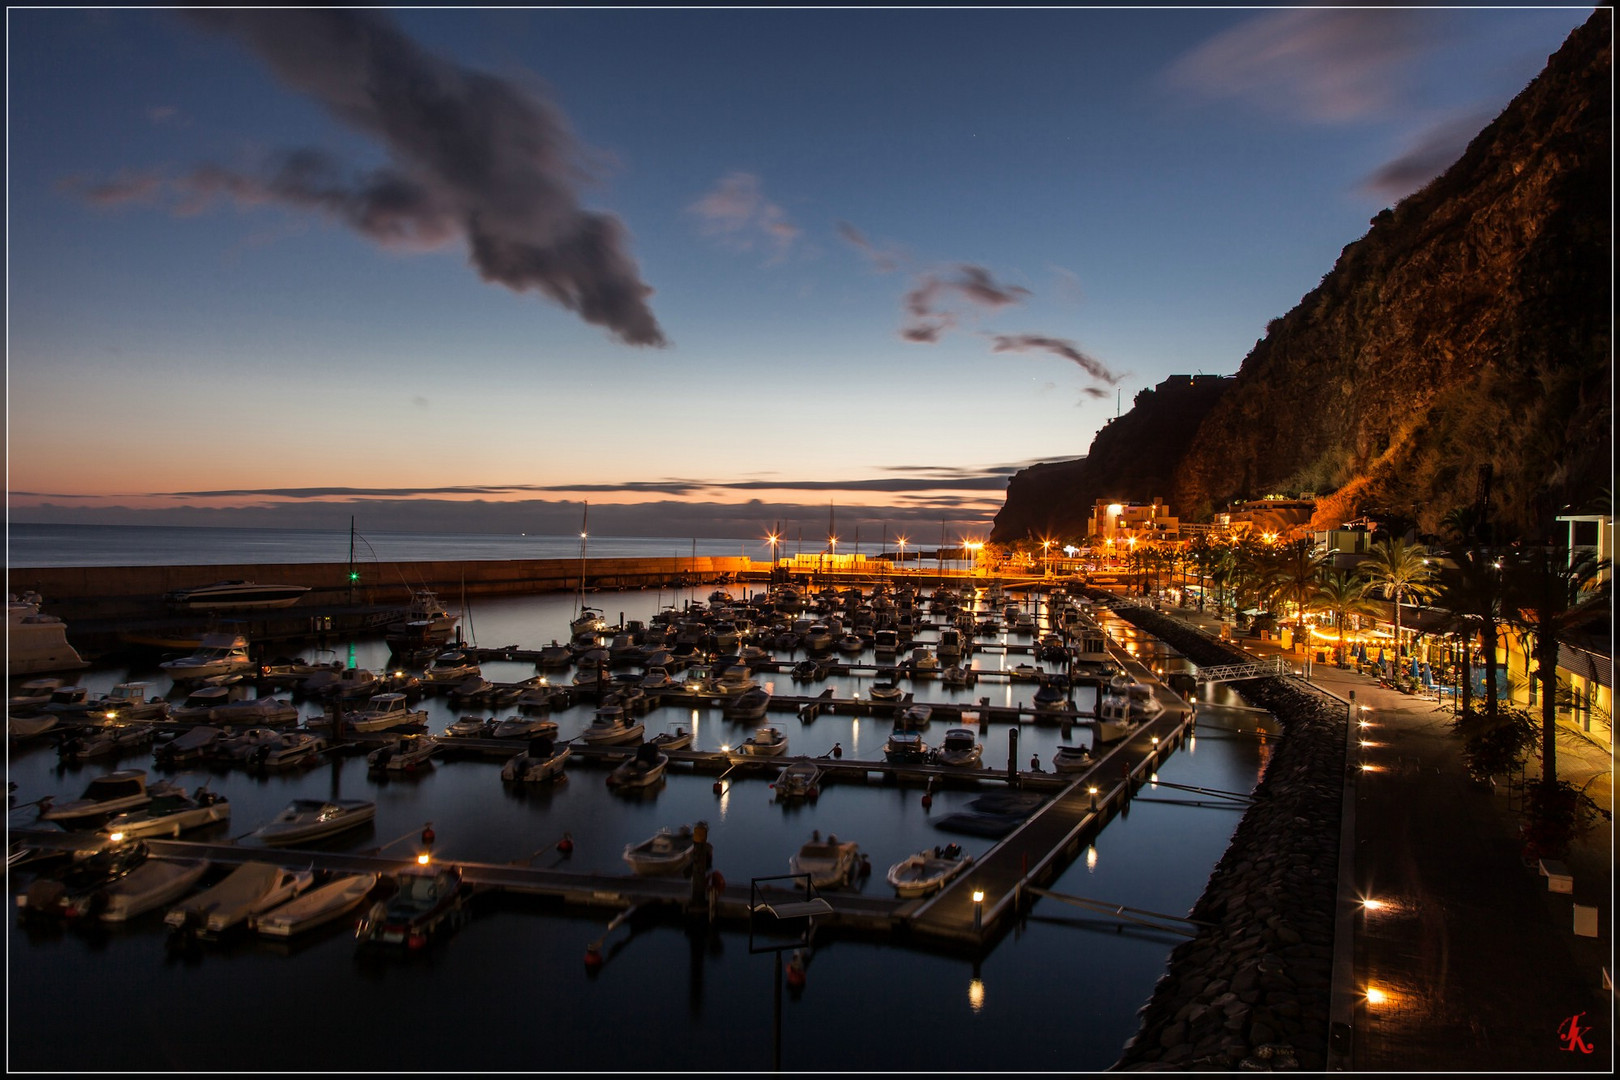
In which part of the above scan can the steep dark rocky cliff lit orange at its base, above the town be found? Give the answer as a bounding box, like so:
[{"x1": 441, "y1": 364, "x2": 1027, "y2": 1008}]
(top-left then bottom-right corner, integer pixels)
[{"x1": 991, "y1": 8, "x2": 1614, "y2": 541}]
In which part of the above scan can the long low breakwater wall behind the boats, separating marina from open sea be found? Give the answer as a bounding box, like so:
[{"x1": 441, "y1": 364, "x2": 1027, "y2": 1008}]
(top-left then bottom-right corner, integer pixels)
[{"x1": 6, "y1": 555, "x2": 754, "y2": 623}]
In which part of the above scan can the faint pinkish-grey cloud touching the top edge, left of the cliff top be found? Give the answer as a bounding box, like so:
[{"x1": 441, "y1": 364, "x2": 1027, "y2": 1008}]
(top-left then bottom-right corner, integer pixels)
[{"x1": 1165, "y1": 8, "x2": 1440, "y2": 123}]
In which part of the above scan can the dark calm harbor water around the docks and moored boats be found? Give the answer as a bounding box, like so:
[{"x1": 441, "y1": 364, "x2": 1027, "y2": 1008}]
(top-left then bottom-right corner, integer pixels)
[{"x1": 6, "y1": 586, "x2": 1272, "y2": 1072}]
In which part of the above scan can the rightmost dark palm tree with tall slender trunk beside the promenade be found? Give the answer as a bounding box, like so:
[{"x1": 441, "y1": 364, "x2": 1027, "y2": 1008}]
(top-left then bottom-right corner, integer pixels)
[{"x1": 1507, "y1": 546, "x2": 1610, "y2": 785}]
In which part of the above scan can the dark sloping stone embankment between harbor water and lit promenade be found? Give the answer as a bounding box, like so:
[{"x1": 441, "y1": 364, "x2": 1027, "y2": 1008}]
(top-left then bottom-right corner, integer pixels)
[{"x1": 1095, "y1": 609, "x2": 1349, "y2": 1072}]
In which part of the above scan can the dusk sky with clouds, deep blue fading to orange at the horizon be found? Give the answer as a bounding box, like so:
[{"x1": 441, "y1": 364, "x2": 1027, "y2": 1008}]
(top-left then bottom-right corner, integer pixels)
[{"x1": 6, "y1": 5, "x2": 1591, "y2": 550}]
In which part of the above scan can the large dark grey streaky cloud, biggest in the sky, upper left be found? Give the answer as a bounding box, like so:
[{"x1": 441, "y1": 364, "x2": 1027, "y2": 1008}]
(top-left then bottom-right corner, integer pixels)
[{"x1": 84, "y1": 8, "x2": 666, "y2": 345}]
